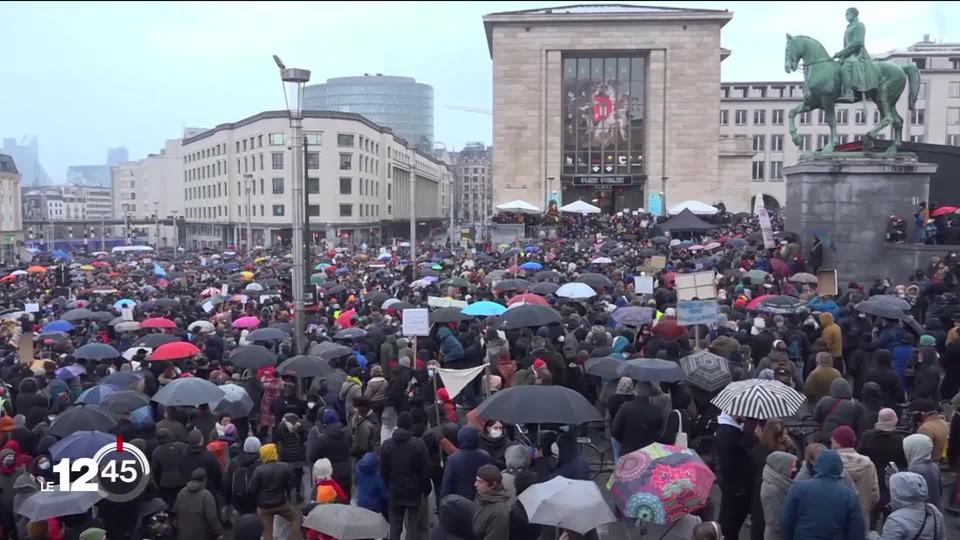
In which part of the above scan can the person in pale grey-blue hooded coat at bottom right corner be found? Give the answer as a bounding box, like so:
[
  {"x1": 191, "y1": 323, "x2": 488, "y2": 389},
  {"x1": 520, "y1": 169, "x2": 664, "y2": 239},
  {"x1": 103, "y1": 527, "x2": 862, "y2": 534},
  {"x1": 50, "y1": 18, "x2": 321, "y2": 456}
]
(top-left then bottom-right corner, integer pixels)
[{"x1": 867, "y1": 472, "x2": 947, "y2": 540}]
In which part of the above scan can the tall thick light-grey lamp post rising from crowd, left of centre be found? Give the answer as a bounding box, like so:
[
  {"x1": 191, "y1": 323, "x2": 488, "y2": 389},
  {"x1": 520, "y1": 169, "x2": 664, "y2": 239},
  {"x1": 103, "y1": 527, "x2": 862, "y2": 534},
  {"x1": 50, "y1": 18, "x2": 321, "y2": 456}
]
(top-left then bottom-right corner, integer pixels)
[{"x1": 273, "y1": 55, "x2": 310, "y2": 354}]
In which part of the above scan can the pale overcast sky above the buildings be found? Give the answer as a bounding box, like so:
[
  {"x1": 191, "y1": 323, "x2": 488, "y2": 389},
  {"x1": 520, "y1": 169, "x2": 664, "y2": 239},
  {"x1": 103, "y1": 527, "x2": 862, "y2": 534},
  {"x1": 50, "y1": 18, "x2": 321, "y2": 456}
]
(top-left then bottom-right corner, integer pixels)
[{"x1": 0, "y1": 0, "x2": 960, "y2": 178}]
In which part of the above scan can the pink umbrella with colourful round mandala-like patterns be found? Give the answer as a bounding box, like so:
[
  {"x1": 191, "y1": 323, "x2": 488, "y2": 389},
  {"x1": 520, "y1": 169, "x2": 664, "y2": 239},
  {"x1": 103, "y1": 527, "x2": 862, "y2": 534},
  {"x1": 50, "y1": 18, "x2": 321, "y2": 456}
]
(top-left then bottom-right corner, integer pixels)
[{"x1": 607, "y1": 443, "x2": 716, "y2": 525}]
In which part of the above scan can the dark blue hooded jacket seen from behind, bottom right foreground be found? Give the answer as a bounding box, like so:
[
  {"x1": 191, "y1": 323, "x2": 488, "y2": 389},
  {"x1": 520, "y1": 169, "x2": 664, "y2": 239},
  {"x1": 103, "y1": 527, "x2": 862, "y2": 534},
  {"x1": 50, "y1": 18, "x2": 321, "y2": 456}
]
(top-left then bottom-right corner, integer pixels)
[{"x1": 780, "y1": 450, "x2": 866, "y2": 540}]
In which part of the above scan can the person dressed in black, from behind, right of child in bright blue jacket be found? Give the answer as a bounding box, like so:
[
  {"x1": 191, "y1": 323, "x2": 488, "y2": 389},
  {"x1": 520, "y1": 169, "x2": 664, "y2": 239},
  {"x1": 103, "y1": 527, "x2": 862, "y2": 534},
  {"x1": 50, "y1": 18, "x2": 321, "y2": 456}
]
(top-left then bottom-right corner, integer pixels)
[{"x1": 380, "y1": 411, "x2": 430, "y2": 540}]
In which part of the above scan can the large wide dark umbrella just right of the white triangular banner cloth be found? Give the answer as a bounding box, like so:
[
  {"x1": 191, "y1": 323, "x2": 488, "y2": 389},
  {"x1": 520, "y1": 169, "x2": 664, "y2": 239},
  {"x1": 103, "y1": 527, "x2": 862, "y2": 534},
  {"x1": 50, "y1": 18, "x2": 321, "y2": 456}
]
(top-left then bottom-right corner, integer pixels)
[{"x1": 477, "y1": 386, "x2": 603, "y2": 424}]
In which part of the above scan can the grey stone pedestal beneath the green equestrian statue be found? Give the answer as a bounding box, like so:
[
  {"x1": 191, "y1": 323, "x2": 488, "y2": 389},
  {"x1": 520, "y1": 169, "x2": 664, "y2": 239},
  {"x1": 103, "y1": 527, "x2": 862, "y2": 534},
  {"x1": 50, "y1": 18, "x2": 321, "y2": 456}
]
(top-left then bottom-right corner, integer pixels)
[{"x1": 783, "y1": 153, "x2": 937, "y2": 288}]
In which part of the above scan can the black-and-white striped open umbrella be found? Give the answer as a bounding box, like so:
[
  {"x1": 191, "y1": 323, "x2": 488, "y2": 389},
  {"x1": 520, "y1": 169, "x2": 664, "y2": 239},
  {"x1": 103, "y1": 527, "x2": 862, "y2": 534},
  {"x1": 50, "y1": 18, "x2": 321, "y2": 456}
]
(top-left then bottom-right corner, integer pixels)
[{"x1": 711, "y1": 379, "x2": 806, "y2": 420}]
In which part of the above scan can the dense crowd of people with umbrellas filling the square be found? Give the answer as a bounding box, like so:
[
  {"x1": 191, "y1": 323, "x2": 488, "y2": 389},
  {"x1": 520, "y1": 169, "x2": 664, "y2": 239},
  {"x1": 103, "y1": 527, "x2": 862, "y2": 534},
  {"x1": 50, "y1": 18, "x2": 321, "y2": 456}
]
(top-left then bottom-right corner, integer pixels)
[{"x1": 0, "y1": 205, "x2": 960, "y2": 540}]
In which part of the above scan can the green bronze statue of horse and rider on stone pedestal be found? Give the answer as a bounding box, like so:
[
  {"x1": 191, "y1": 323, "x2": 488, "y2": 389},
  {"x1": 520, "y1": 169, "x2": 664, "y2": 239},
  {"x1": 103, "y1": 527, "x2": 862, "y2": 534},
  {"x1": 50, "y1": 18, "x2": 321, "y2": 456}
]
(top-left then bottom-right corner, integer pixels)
[{"x1": 784, "y1": 8, "x2": 920, "y2": 154}]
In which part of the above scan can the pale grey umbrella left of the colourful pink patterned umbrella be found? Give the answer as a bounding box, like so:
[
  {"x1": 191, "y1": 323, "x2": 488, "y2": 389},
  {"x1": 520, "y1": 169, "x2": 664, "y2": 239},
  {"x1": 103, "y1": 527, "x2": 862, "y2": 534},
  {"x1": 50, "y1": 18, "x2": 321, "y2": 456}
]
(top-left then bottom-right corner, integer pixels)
[{"x1": 517, "y1": 476, "x2": 617, "y2": 534}]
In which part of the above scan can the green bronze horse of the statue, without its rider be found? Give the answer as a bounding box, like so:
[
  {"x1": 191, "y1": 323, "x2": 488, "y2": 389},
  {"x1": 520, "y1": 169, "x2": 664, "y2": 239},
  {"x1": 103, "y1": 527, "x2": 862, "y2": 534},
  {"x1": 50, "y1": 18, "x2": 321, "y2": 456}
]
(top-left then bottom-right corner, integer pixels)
[{"x1": 784, "y1": 34, "x2": 920, "y2": 154}]
